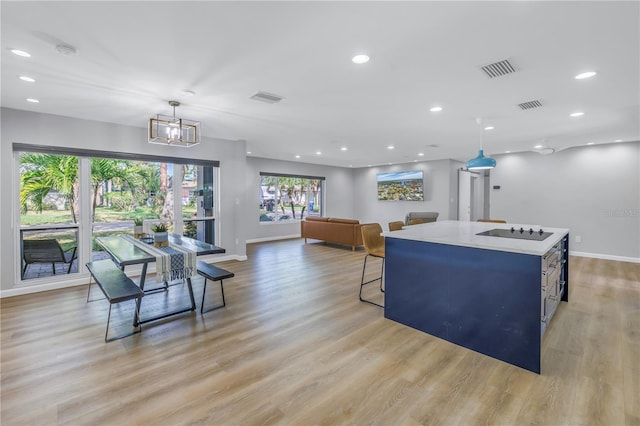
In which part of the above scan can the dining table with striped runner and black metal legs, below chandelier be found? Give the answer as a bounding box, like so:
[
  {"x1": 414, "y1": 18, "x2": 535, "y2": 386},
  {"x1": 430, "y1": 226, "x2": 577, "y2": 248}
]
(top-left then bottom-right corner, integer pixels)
[{"x1": 96, "y1": 234, "x2": 225, "y2": 327}]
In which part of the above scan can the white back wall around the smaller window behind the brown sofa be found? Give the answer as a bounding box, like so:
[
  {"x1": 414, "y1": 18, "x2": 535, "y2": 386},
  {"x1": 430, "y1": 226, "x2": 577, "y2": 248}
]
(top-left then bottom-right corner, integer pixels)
[{"x1": 245, "y1": 157, "x2": 354, "y2": 241}]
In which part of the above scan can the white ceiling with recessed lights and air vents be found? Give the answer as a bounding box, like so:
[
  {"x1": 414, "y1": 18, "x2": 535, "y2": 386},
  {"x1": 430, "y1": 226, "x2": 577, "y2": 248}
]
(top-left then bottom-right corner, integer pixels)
[{"x1": 0, "y1": 1, "x2": 640, "y2": 167}]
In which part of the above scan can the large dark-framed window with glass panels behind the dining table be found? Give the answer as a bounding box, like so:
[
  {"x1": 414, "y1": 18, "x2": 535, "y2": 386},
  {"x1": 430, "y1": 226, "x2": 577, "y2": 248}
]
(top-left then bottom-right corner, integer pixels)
[{"x1": 14, "y1": 144, "x2": 218, "y2": 280}]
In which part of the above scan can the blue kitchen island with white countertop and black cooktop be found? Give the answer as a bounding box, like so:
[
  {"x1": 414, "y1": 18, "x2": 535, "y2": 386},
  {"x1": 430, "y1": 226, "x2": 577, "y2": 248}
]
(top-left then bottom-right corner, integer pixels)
[{"x1": 383, "y1": 221, "x2": 569, "y2": 374}]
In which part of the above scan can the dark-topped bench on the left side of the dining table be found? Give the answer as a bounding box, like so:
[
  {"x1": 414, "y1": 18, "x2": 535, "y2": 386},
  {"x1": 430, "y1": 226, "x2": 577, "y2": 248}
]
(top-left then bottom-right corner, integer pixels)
[{"x1": 86, "y1": 259, "x2": 144, "y2": 342}]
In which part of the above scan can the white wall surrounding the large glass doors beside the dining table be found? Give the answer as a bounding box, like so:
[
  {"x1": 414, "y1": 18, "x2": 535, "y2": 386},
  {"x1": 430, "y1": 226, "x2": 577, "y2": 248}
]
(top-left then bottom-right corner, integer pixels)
[{"x1": 0, "y1": 108, "x2": 247, "y2": 290}]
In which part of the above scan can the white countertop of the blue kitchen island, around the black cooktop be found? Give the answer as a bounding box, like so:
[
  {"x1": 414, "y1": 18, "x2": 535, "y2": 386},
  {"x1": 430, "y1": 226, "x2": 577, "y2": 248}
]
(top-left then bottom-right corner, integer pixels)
[{"x1": 382, "y1": 220, "x2": 569, "y2": 256}]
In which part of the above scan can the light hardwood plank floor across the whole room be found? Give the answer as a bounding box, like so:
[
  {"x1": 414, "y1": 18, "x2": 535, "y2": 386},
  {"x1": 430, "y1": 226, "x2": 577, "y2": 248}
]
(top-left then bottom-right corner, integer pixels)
[{"x1": 0, "y1": 240, "x2": 640, "y2": 426}]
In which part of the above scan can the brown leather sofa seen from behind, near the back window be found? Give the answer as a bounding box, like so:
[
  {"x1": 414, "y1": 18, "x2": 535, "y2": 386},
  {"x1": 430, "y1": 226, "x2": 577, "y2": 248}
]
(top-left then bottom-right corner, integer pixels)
[{"x1": 300, "y1": 216, "x2": 362, "y2": 250}]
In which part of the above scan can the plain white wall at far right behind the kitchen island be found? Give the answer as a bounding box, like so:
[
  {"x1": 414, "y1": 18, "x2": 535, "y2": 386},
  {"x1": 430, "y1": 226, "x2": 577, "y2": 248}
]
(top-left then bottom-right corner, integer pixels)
[{"x1": 489, "y1": 142, "x2": 640, "y2": 261}]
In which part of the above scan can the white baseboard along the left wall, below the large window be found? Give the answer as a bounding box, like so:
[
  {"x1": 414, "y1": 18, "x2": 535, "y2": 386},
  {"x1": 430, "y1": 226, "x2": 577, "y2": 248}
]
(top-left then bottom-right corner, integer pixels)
[{"x1": 0, "y1": 255, "x2": 247, "y2": 299}]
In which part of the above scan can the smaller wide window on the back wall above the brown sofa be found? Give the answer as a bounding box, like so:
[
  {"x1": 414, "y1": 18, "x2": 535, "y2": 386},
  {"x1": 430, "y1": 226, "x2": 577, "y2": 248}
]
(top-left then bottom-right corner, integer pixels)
[{"x1": 258, "y1": 173, "x2": 324, "y2": 222}]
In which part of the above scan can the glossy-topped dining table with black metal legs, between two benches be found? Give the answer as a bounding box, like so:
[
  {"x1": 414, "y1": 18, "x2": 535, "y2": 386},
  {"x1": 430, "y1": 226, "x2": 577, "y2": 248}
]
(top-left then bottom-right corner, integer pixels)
[{"x1": 96, "y1": 234, "x2": 226, "y2": 326}]
